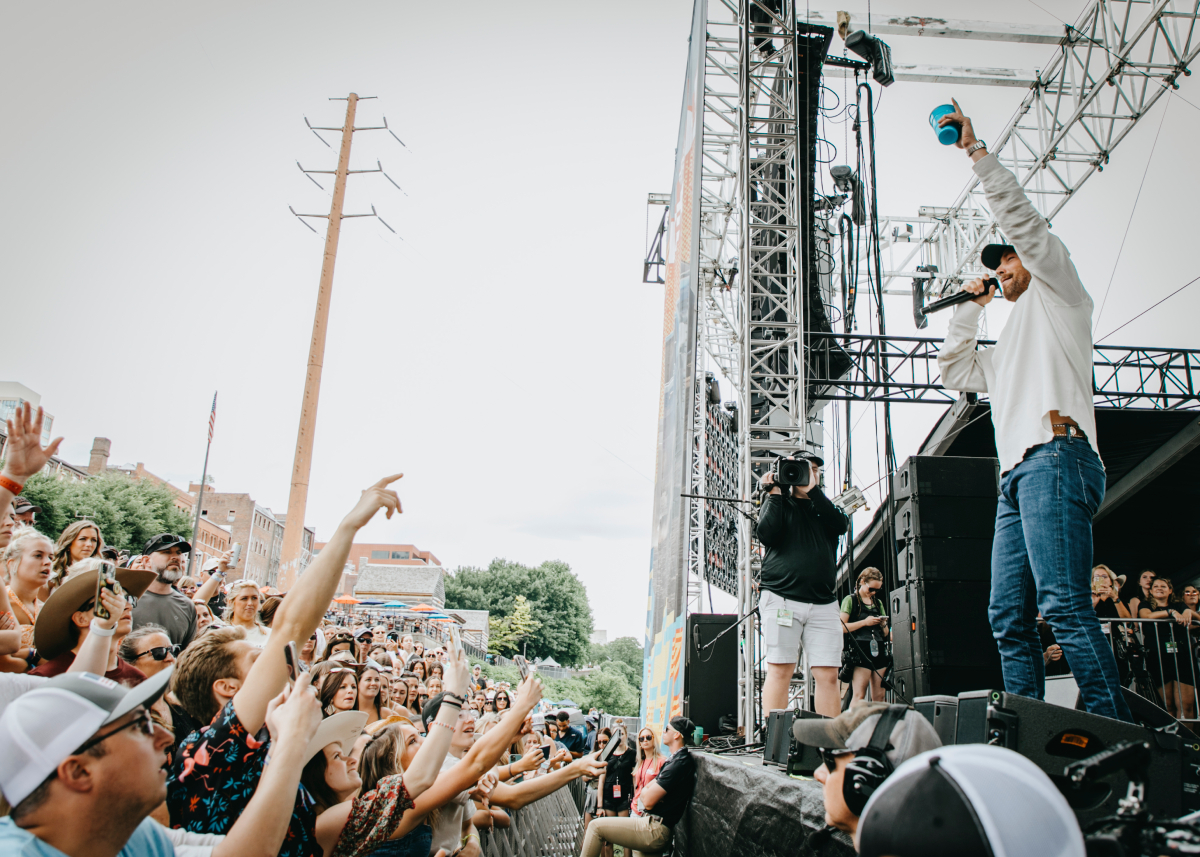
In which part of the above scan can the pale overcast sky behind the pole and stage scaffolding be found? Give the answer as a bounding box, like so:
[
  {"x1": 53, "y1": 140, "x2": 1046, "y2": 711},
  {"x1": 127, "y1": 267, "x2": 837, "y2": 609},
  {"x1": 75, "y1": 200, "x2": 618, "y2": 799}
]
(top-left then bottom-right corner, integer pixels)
[{"x1": 0, "y1": 0, "x2": 1200, "y2": 637}]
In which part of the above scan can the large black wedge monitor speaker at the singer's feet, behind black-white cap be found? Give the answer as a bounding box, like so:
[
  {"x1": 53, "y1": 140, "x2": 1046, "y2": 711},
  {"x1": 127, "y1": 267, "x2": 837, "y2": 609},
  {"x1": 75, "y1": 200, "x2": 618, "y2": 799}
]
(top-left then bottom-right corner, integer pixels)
[{"x1": 955, "y1": 690, "x2": 1196, "y2": 826}]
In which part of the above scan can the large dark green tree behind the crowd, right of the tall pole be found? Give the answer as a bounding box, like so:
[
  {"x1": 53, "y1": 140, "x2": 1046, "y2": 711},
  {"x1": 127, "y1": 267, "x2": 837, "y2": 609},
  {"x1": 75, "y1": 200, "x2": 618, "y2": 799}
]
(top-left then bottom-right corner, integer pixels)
[{"x1": 445, "y1": 559, "x2": 592, "y2": 666}]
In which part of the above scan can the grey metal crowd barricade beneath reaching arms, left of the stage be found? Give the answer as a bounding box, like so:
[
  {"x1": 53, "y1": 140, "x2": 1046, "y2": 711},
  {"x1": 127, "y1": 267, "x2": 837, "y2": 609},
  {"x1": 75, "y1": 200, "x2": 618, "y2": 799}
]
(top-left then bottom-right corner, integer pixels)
[{"x1": 479, "y1": 780, "x2": 583, "y2": 857}]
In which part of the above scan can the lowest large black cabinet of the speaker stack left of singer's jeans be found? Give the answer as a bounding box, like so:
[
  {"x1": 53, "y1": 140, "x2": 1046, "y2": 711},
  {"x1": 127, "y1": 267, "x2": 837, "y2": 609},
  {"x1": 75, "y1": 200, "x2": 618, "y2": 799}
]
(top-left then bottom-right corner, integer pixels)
[{"x1": 888, "y1": 580, "x2": 1000, "y2": 672}]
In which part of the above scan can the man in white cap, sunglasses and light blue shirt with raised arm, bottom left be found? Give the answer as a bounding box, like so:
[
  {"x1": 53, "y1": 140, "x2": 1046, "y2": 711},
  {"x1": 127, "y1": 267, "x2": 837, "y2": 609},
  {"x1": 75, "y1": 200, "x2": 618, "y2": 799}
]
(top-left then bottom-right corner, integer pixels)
[{"x1": 0, "y1": 669, "x2": 320, "y2": 857}]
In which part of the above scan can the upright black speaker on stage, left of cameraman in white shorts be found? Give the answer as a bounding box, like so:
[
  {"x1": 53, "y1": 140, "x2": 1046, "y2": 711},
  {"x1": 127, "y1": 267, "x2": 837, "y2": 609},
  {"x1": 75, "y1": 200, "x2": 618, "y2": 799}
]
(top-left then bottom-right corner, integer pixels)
[{"x1": 683, "y1": 613, "x2": 738, "y2": 735}]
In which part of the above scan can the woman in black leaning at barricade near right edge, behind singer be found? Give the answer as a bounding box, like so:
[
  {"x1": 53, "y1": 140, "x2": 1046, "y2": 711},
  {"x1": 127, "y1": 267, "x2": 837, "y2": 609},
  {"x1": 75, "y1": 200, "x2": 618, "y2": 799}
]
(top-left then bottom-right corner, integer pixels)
[{"x1": 1139, "y1": 577, "x2": 1196, "y2": 719}]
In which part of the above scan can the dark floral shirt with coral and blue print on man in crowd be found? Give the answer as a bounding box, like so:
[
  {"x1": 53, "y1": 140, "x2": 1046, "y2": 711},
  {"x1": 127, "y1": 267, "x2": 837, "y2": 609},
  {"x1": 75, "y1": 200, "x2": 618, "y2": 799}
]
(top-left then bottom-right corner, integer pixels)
[{"x1": 167, "y1": 701, "x2": 322, "y2": 857}]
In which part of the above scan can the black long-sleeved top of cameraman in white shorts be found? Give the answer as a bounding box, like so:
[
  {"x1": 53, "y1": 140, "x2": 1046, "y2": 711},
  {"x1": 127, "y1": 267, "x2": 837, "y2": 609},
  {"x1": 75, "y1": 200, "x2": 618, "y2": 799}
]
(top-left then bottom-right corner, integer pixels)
[{"x1": 755, "y1": 487, "x2": 850, "y2": 604}]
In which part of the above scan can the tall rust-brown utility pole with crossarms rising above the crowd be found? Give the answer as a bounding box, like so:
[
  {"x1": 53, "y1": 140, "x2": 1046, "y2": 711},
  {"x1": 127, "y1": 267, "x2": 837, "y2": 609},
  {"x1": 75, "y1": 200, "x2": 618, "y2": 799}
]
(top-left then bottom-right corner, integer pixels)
[{"x1": 277, "y1": 92, "x2": 407, "y2": 591}]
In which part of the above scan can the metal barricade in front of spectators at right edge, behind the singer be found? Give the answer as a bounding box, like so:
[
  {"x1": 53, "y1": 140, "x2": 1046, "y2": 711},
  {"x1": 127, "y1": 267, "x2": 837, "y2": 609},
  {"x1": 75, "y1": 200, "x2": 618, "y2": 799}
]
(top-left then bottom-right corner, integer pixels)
[{"x1": 1100, "y1": 619, "x2": 1200, "y2": 724}]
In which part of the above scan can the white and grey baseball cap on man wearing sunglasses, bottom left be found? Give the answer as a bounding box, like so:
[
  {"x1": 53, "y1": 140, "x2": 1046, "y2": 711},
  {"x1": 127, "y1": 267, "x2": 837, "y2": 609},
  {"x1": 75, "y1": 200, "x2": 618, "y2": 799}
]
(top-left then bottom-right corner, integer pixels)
[{"x1": 0, "y1": 665, "x2": 175, "y2": 807}]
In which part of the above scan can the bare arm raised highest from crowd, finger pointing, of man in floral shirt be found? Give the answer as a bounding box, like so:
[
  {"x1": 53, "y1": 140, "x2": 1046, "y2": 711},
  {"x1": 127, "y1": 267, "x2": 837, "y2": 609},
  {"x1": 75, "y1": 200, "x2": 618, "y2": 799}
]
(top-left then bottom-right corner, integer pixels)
[{"x1": 233, "y1": 473, "x2": 403, "y2": 735}]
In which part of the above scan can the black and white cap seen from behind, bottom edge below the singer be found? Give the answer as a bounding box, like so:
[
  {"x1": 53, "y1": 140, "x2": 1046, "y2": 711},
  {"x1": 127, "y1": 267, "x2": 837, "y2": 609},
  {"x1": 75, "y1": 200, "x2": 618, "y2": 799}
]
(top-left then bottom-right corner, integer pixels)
[{"x1": 858, "y1": 744, "x2": 1086, "y2": 857}]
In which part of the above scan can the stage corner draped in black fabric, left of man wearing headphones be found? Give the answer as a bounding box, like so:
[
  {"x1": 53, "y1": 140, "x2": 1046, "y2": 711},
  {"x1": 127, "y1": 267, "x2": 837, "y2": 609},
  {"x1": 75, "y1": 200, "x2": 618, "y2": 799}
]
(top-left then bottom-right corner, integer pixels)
[{"x1": 674, "y1": 750, "x2": 854, "y2": 857}]
